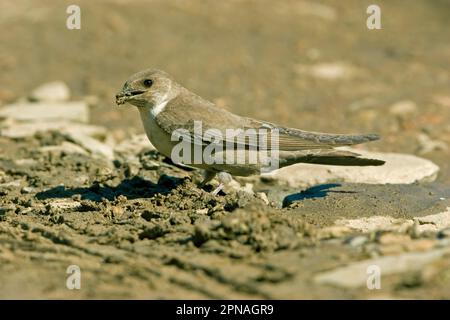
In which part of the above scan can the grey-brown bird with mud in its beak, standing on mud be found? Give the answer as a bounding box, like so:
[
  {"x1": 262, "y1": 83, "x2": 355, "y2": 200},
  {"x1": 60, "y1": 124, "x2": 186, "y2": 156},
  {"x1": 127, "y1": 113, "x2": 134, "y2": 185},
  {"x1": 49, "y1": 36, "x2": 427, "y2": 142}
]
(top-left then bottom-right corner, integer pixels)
[{"x1": 116, "y1": 69, "x2": 384, "y2": 195}]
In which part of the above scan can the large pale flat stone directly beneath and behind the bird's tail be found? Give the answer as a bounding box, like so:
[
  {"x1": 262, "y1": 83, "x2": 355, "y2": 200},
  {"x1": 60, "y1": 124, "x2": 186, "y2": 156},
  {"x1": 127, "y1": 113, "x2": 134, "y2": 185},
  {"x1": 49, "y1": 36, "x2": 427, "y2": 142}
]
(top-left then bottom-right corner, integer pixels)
[{"x1": 262, "y1": 148, "x2": 439, "y2": 188}]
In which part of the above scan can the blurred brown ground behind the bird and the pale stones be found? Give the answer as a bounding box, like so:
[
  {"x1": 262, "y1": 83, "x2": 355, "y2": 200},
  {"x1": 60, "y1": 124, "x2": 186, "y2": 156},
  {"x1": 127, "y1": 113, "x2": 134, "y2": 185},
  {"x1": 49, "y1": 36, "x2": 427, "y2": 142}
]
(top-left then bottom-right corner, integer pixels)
[{"x1": 0, "y1": 0, "x2": 450, "y2": 182}]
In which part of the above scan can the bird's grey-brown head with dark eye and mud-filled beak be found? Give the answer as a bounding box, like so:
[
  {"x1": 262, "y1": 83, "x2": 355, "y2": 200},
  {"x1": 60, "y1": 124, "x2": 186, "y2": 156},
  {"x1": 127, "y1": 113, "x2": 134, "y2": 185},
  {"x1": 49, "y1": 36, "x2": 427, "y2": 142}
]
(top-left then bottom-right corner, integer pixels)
[{"x1": 116, "y1": 69, "x2": 178, "y2": 108}]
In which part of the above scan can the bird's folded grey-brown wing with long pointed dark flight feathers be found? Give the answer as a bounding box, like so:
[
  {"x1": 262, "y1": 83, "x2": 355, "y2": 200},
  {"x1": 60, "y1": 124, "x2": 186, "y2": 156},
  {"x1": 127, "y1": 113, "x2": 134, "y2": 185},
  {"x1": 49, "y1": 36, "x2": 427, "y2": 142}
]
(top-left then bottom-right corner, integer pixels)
[{"x1": 156, "y1": 96, "x2": 378, "y2": 151}]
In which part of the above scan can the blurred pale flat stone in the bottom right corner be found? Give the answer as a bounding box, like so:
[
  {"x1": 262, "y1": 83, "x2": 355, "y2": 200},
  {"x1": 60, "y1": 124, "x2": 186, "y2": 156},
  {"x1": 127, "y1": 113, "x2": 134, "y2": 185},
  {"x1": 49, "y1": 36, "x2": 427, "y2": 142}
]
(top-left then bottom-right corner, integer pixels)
[{"x1": 314, "y1": 248, "x2": 450, "y2": 289}]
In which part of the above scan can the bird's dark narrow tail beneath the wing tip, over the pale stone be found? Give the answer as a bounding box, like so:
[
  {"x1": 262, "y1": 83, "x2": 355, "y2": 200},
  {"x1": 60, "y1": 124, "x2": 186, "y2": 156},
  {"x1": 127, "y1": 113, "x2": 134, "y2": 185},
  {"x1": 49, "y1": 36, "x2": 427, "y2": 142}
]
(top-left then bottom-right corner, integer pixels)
[{"x1": 279, "y1": 149, "x2": 385, "y2": 167}]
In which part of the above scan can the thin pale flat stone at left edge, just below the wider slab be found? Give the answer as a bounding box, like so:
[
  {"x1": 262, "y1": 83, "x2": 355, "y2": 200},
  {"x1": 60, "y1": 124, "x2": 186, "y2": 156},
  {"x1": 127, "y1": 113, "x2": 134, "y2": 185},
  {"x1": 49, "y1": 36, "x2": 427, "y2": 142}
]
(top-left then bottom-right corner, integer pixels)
[{"x1": 0, "y1": 121, "x2": 106, "y2": 139}]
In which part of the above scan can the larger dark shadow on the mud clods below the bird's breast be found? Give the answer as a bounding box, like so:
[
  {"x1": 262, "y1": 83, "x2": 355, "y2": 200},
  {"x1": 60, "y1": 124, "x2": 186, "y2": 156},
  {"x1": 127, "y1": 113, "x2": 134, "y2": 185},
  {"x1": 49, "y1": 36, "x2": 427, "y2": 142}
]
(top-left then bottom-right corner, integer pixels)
[{"x1": 36, "y1": 175, "x2": 184, "y2": 202}]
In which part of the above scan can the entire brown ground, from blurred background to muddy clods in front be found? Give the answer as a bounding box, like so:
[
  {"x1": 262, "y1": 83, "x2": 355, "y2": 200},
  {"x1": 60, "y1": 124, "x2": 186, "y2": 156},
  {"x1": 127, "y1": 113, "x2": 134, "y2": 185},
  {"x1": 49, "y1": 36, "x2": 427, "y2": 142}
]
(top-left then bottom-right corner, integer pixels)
[{"x1": 0, "y1": 0, "x2": 450, "y2": 299}]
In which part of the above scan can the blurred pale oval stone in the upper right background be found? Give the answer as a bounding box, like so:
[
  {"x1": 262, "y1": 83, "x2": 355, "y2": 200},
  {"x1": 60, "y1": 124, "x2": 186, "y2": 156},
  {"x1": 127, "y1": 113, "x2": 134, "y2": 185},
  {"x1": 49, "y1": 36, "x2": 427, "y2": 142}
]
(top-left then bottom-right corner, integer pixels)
[{"x1": 296, "y1": 62, "x2": 358, "y2": 80}]
